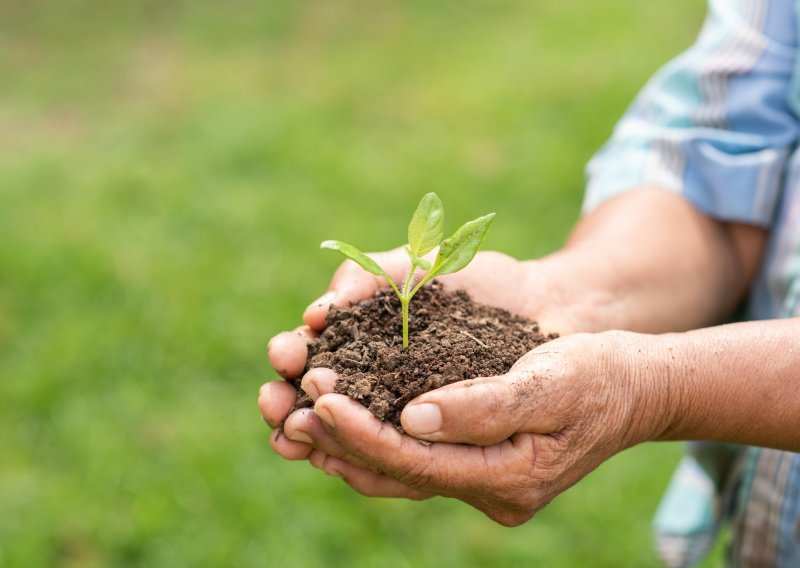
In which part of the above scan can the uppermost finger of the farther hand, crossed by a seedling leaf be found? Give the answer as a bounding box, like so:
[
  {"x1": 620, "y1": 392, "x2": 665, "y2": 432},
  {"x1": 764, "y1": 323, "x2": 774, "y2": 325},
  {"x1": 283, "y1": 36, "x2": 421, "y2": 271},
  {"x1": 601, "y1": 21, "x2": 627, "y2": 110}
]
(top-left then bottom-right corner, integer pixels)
[{"x1": 303, "y1": 248, "x2": 409, "y2": 331}]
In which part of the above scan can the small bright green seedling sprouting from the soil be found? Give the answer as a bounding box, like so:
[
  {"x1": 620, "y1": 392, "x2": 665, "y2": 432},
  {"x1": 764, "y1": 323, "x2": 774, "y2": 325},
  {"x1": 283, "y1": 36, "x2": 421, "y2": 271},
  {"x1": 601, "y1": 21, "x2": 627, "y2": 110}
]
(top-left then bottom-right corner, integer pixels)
[{"x1": 320, "y1": 193, "x2": 494, "y2": 349}]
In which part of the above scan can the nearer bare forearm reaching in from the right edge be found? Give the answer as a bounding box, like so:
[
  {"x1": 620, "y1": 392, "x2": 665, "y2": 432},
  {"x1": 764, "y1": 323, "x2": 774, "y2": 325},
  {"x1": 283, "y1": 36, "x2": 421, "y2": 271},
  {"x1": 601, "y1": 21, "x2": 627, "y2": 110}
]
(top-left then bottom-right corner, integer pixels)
[{"x1": 634, "y1": 318, "x2": 800, "y2": 451}]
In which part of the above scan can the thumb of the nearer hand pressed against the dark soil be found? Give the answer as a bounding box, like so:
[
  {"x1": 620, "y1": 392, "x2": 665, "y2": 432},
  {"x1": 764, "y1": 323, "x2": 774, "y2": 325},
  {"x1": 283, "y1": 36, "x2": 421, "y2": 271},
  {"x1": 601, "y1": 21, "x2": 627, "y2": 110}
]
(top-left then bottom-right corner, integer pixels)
[{"x1": 400, "y1": 375, "x2": 527, "y2": 446}]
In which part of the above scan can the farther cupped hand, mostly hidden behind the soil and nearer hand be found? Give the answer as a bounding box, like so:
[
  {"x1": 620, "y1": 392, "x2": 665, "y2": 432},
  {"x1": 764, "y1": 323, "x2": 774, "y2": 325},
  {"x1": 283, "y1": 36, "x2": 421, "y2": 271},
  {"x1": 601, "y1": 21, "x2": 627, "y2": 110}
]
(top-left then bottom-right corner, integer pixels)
[{"x1": 259, "y1": 249, "x2": 571, "y2": 466}]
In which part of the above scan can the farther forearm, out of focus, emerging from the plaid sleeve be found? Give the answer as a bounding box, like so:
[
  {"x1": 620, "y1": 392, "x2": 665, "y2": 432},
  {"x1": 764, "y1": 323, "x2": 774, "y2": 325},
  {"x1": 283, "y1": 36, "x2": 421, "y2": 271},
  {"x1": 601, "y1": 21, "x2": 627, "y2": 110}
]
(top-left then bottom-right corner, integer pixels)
[{"x1": 537, "y1": 189, "x2": 764, "y2": 332}]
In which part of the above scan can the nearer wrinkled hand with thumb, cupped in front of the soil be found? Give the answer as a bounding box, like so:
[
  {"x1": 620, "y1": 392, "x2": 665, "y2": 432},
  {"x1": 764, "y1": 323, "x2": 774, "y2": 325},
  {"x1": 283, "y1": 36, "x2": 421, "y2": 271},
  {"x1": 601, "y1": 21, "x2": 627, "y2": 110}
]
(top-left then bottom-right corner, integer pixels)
[{"x1": 278, "y1": 332, "x2": 668, "y2": 526}]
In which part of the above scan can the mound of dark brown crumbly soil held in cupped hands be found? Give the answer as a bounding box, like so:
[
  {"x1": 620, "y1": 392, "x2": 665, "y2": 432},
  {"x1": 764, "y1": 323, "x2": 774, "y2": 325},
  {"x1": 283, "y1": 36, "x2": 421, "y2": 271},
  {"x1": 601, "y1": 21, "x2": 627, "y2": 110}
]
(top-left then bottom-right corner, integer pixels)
[{"x1": 295, "y1": 281, "x2": 557, "y2": 431}]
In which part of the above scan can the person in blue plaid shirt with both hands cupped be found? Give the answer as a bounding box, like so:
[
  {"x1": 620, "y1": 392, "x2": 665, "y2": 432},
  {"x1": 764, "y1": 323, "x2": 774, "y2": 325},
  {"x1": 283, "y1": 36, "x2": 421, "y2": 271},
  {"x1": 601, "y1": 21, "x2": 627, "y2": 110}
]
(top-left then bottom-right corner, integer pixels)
[{"x1": 259, "y1": 0, "x2": 800, "y2": 566}]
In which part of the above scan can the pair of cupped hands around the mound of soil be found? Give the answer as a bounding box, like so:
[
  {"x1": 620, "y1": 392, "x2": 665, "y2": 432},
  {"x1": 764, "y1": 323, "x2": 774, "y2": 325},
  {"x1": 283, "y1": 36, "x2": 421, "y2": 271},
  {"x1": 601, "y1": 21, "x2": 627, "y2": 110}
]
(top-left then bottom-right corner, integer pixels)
[{"x1": 259, "y1": 250, "x2": 659, "y2": 526}]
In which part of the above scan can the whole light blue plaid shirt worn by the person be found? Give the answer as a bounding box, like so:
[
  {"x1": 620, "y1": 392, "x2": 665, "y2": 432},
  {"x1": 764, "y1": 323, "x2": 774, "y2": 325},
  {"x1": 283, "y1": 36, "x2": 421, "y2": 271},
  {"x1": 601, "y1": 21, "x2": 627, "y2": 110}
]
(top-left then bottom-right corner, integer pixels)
[{"x1": 584, "y1": 0, "x2": 800, "y2": 567}]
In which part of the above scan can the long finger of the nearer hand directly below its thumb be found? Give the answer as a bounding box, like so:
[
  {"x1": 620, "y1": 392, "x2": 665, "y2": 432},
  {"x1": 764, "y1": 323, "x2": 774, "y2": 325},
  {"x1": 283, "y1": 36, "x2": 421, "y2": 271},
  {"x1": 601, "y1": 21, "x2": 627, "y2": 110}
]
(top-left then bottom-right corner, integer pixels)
[{"x1": 314, "y1": 394, "x2": 532, "y2": 496}]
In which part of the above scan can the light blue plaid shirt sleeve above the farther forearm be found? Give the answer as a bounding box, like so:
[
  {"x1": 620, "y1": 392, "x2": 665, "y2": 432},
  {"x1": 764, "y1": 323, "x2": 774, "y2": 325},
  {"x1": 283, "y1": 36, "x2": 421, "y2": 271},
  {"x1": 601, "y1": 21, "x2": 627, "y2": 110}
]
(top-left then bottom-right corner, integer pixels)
[{"x1": 583, "y1": 0, "x2": 798, "y2": 226}]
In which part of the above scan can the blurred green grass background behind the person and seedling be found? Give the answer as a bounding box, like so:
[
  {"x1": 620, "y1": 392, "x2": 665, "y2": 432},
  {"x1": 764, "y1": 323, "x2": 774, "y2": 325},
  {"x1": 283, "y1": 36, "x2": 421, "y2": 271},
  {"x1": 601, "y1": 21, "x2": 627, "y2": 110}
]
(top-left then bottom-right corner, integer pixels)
[{"x1": 0, "y1": 0, "x2": 704, "y2": 567}]
